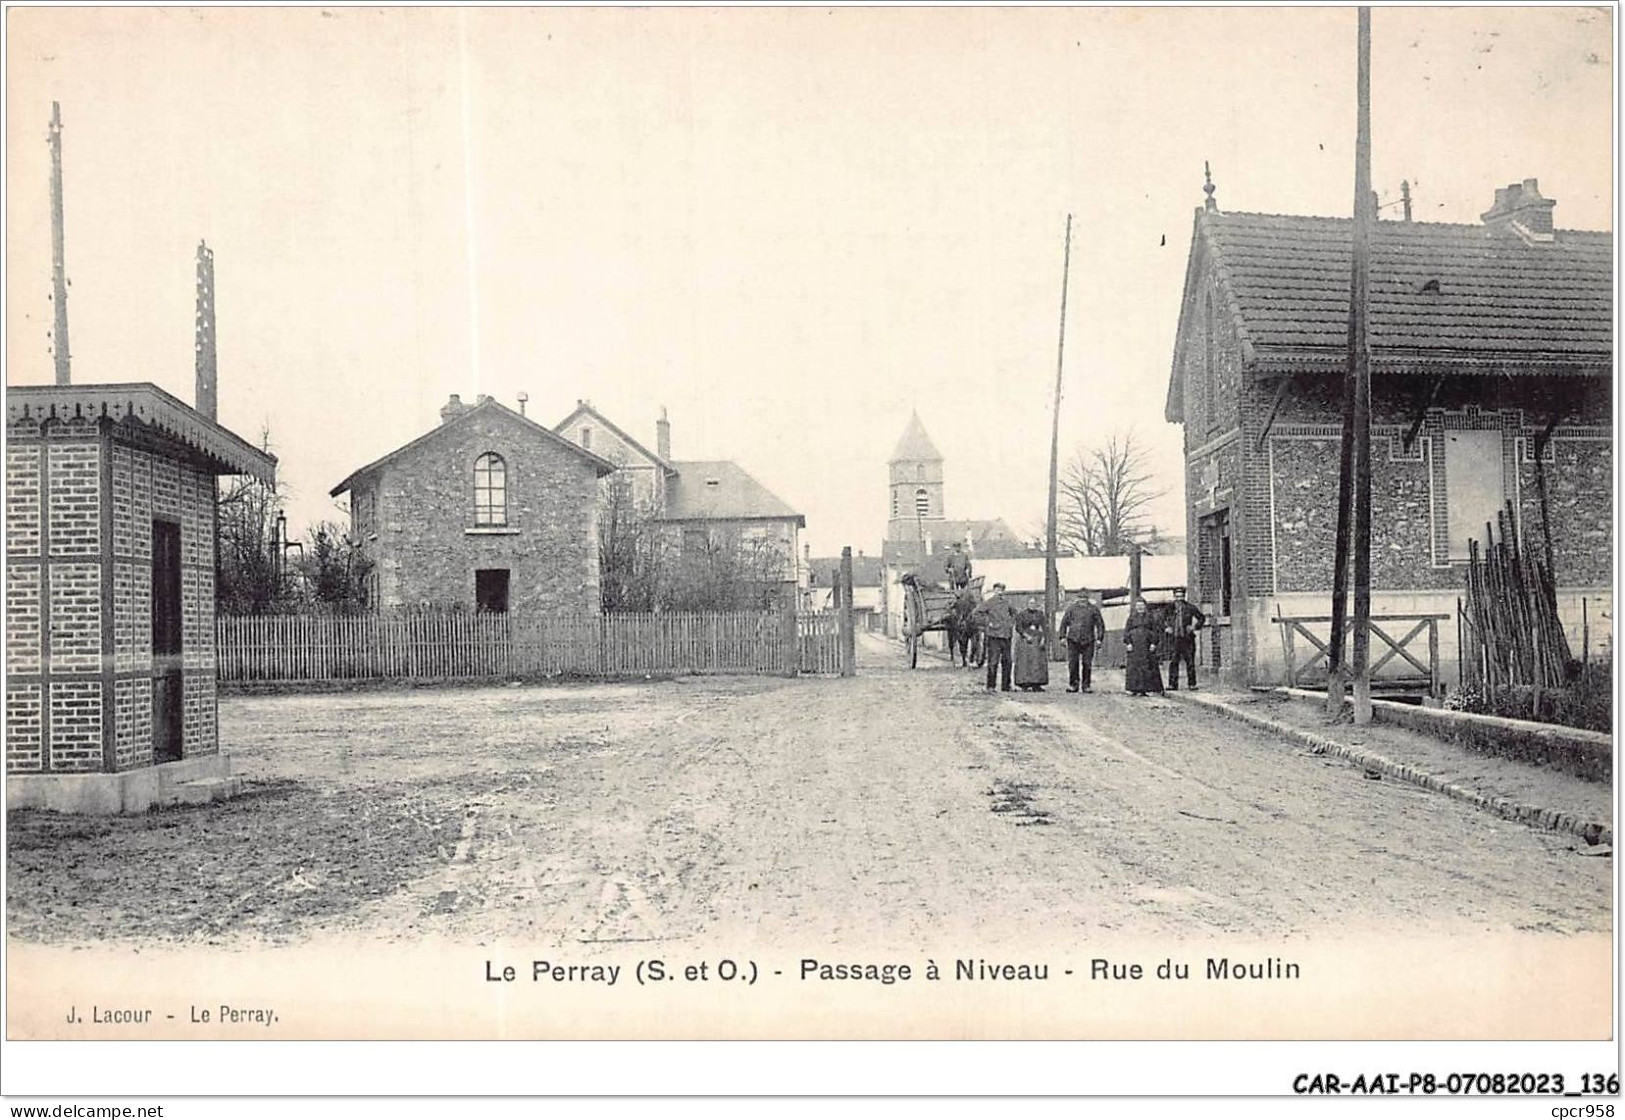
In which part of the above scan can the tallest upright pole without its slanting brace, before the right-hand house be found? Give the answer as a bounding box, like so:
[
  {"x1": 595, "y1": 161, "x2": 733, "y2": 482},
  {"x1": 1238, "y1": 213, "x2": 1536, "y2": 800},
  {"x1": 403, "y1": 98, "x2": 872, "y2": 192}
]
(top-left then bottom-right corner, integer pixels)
[{"x1": 1349, "y1": 8, "x2": 1376, "y2": 725}]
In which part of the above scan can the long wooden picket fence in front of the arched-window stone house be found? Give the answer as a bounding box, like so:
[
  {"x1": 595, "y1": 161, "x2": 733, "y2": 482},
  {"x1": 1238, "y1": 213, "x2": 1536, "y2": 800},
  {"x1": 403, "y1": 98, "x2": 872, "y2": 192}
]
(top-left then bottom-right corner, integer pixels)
[{"x1": 215, "y1": 611, "x2": 840, "y2": 683}]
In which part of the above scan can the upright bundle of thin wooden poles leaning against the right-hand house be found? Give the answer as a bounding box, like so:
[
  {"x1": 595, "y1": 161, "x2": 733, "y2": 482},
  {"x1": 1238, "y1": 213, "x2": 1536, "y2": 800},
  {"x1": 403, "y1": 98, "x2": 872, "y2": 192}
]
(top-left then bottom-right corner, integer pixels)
[{"x1": 1463, "y1": 504, "x2": 1570, "y2": 705}]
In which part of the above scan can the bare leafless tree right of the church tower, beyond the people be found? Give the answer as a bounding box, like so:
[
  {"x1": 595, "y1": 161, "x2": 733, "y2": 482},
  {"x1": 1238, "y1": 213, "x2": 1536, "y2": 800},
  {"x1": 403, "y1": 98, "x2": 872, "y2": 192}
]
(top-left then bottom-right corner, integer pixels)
[{"x1": 1058, "y1": 429, "x2": 1167, "y2": 556}]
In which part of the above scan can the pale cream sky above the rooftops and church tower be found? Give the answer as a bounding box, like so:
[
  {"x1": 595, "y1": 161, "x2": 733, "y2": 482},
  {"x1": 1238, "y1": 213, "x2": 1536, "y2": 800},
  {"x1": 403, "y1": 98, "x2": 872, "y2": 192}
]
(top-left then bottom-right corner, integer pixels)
[{"x1": 5, "y1": 8, "x2": 1614, "y2": 554}]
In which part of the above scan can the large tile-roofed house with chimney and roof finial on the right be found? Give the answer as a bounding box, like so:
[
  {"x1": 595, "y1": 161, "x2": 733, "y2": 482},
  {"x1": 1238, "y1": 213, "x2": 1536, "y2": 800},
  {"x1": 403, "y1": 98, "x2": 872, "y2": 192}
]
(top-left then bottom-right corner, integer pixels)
[{"x1": 1165, "y1": 179, "x2": 1614, "y2": 684}]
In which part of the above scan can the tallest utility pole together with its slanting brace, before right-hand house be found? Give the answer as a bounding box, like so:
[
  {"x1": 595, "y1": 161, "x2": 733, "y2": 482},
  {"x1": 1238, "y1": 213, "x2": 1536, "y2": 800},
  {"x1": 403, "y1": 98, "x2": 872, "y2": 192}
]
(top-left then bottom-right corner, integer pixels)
[{"x1": 1326, "y1": 8, "x2": 1373, "y2": 720}]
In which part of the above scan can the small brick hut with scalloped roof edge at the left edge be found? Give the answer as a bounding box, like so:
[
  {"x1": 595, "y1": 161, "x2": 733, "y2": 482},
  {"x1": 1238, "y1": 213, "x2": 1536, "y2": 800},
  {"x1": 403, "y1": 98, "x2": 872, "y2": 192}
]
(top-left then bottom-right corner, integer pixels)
[{"x1": 5, "y1": 384, "x2": 276, "y2": 811}]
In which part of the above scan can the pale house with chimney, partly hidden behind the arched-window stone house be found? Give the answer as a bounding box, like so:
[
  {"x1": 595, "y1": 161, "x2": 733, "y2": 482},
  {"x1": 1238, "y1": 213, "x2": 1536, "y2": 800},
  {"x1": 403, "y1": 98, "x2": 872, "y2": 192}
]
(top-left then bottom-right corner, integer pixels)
[{"x1": 553, "y1": 400, "x2": 808, "y2": 605}]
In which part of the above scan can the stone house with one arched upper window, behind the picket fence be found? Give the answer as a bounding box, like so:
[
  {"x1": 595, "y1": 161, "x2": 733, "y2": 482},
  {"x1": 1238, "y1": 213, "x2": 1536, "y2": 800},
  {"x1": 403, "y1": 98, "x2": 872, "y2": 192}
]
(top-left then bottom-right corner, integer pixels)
[{"x1": 332, "y1": 395, "x2": 614, "y2": 614}]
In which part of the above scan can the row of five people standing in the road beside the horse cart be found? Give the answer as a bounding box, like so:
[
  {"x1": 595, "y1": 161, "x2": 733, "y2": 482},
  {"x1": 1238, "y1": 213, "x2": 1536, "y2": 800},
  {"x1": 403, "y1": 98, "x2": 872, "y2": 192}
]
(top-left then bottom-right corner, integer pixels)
[{"x1": 972, "y1": 584, "x2": 1207, "y2": 696}]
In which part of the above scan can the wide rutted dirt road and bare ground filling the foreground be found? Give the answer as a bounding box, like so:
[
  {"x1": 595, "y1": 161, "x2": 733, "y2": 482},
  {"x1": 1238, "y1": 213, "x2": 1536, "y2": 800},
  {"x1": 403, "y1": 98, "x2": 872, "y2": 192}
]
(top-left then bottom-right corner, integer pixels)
[{"x1": 10, "y1": 637, "x2": 1612, "y2": 944}]
